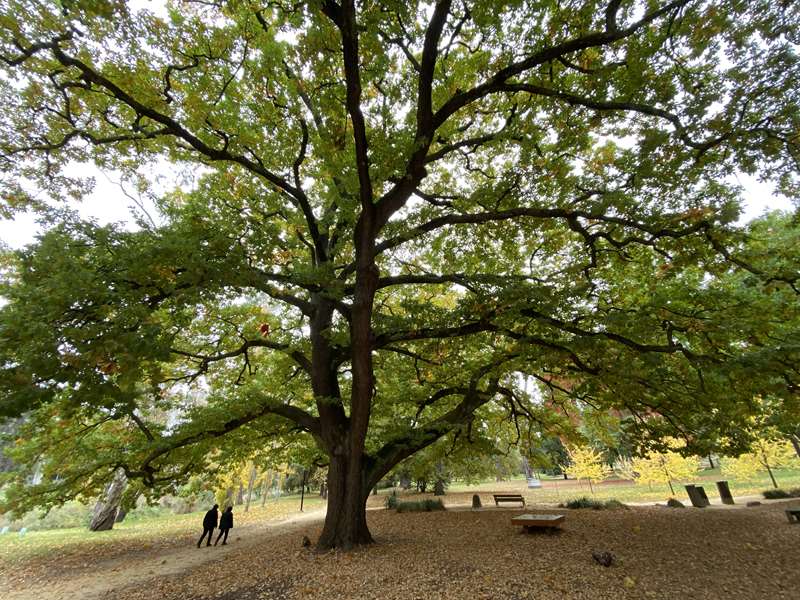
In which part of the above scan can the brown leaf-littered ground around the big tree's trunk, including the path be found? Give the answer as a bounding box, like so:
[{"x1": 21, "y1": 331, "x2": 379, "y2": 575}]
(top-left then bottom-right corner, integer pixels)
[{"x1": 2, "y1": 495, "x2": 800, "y2": 600}]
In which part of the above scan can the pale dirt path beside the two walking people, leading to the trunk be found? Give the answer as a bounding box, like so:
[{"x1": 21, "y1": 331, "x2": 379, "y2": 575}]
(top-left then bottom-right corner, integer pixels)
[{"x1": 3, "y1": 509, "x2": 325, "y2": 600}]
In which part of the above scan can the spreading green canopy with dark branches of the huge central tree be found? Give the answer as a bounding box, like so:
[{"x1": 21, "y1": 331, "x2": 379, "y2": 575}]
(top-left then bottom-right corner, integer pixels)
[{"x1": 0, "y1": 0, "x2": 800, "y2": 543}]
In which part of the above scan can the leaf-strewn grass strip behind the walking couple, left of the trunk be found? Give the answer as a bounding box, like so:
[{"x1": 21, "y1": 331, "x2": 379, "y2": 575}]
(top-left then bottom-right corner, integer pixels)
[{"x1": 0, "y1": 494, "x2": 325, "y2": 568}]
